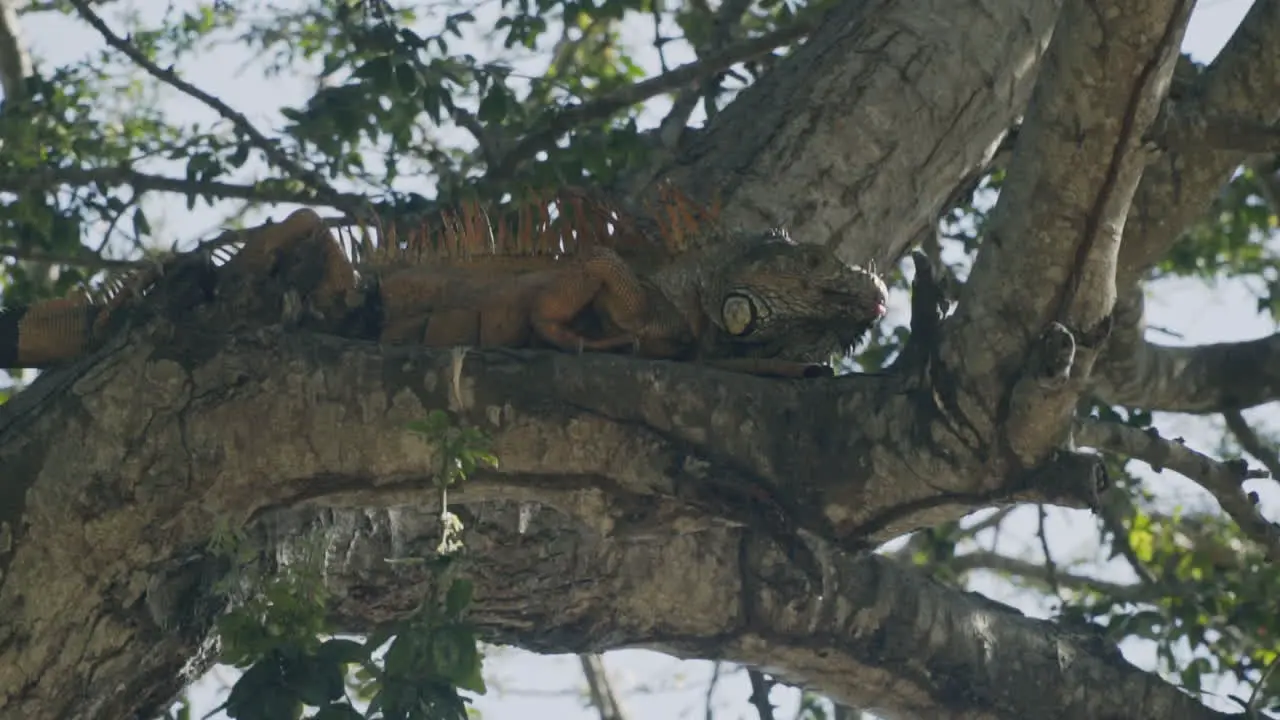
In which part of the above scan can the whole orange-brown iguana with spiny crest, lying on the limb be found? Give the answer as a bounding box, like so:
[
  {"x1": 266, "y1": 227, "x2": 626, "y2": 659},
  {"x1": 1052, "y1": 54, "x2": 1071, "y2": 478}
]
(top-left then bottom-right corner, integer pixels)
[{"x1": 0, "y1": 183, "x2": 887, "y2": 377}]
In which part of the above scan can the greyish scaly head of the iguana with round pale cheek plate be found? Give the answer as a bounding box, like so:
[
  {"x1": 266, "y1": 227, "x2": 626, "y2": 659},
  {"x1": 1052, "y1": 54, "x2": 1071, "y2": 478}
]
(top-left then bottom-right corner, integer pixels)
[{"x1": 701, "y1": 229, "x2": 888, "y2": 363}]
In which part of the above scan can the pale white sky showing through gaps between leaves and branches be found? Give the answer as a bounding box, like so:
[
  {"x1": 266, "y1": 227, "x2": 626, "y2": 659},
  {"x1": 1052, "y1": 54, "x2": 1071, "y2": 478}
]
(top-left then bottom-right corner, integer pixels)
[{"x1": 10, "y1": 0, "x2": 1280, "y2": 720}]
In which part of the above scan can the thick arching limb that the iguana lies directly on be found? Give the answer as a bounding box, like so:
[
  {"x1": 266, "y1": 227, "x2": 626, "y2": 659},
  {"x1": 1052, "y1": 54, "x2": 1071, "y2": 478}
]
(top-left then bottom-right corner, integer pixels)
[{"x1": 0, "y1": 313, "x2": 1111, "y2": 720}]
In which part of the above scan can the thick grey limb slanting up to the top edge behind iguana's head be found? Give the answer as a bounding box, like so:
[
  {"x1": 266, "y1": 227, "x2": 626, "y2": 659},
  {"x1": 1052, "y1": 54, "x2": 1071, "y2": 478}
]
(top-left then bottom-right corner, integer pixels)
[{"x1": 660, "y1": 0, "x2": 1060, "y2": 266}]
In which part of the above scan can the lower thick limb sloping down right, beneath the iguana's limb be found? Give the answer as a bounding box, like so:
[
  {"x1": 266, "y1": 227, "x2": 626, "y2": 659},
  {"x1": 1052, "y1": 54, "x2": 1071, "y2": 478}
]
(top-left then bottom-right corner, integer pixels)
[{"x1": 285, "y1": 506, "x2": 1229, "y2": 720}]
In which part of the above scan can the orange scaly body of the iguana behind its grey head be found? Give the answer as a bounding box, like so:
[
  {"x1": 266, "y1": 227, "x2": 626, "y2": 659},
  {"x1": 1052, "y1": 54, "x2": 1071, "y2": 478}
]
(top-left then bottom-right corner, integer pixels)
[{"x1": 228, "y1": 196, "x2": 670, "y2": 351}]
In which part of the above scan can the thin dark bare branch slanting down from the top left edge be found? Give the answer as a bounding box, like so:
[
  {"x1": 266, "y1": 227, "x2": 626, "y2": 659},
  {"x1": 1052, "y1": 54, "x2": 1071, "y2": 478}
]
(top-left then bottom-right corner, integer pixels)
[{"x1": 72, "y1": 0, "x2": 361, "y2": 214}]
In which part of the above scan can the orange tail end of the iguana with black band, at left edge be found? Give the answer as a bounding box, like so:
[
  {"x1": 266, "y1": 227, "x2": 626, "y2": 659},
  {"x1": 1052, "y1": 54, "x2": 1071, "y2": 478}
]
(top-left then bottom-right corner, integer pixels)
[{"x1": 0, "y1": 297, "x2": 102, "y2": 369}]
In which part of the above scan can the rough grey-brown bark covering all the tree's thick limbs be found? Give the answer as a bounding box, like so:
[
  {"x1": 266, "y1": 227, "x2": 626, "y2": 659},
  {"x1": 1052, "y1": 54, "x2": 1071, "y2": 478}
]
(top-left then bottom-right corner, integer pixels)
[{"x1": 0, "y1": 0, "x2": 1280, "y2": 720}]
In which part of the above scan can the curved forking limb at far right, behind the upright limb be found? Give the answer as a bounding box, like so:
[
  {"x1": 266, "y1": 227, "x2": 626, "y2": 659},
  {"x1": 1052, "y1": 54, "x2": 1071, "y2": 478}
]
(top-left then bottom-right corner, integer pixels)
[{"x1": 1091, "y1": 0, "x2": 1280, "y2": 413}]
